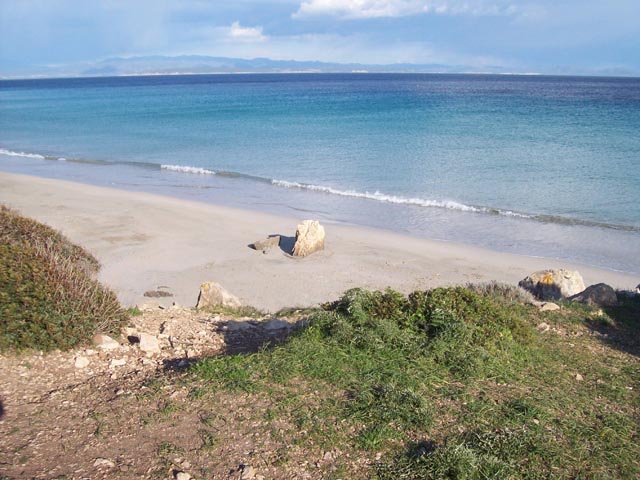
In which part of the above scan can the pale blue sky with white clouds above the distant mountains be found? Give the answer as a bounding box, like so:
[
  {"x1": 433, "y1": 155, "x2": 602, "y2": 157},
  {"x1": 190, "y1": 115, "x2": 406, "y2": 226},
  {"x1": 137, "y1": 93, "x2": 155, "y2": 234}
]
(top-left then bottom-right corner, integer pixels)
[{"x1": 0, "y1": 0, "x2": 640, "y2": 75}]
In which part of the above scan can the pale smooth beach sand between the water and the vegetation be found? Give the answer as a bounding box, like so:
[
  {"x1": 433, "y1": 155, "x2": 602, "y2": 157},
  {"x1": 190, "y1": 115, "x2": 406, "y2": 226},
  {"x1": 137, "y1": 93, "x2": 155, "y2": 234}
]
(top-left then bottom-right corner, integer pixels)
[{"x1": 0, "y1": 172, "x2": 640, "y2": 312}]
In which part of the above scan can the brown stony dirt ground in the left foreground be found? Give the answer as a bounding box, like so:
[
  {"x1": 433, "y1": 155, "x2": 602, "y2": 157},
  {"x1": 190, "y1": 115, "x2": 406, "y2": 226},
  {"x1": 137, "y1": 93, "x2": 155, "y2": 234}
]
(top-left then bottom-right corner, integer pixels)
[{"x1": 0, "y1": 307, "x2": 352, "y2": 480}]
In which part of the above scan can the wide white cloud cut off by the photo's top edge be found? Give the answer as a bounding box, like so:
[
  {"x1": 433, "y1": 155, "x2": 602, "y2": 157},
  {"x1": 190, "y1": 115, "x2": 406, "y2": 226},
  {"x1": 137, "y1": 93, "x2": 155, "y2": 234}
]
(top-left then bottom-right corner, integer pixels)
[{"x1": 293, "y1": 0, "x2": 518, "y2": 19}]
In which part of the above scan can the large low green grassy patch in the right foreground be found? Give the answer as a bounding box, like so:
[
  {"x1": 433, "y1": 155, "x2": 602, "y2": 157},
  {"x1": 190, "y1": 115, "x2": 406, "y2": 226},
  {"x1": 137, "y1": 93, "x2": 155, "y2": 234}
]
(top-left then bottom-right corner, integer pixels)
[{"x1": 192, "y1": 284, "x2": 640, "y2": 479}]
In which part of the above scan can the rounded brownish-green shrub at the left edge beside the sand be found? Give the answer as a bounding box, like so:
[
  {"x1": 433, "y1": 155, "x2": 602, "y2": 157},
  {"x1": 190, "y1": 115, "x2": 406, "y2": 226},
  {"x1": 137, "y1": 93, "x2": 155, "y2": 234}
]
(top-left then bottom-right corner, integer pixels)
[{"x1": 0, "y1": 206, "x2": 127, "y2": 351}]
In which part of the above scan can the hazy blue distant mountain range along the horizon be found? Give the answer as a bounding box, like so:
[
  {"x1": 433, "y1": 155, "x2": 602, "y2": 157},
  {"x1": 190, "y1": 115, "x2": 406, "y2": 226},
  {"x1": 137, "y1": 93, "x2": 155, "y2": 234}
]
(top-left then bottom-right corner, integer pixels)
[{"x1": 0, "y1": 55, "x2": 634, "y2": 79}]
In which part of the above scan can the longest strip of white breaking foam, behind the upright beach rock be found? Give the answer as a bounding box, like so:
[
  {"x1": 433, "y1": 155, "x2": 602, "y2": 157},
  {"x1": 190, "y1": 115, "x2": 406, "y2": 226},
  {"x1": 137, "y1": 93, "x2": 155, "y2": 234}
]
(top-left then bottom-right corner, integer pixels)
[{"x1": 271, "y1": 180, "x2": 530, "y2": 218}]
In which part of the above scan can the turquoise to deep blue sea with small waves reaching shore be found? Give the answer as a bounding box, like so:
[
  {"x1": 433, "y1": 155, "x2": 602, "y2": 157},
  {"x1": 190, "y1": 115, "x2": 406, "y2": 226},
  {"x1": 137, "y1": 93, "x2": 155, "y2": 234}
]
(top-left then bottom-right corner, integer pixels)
[{"x1": 0, "y1": 73, "x2": 640, "y2": 274}]
